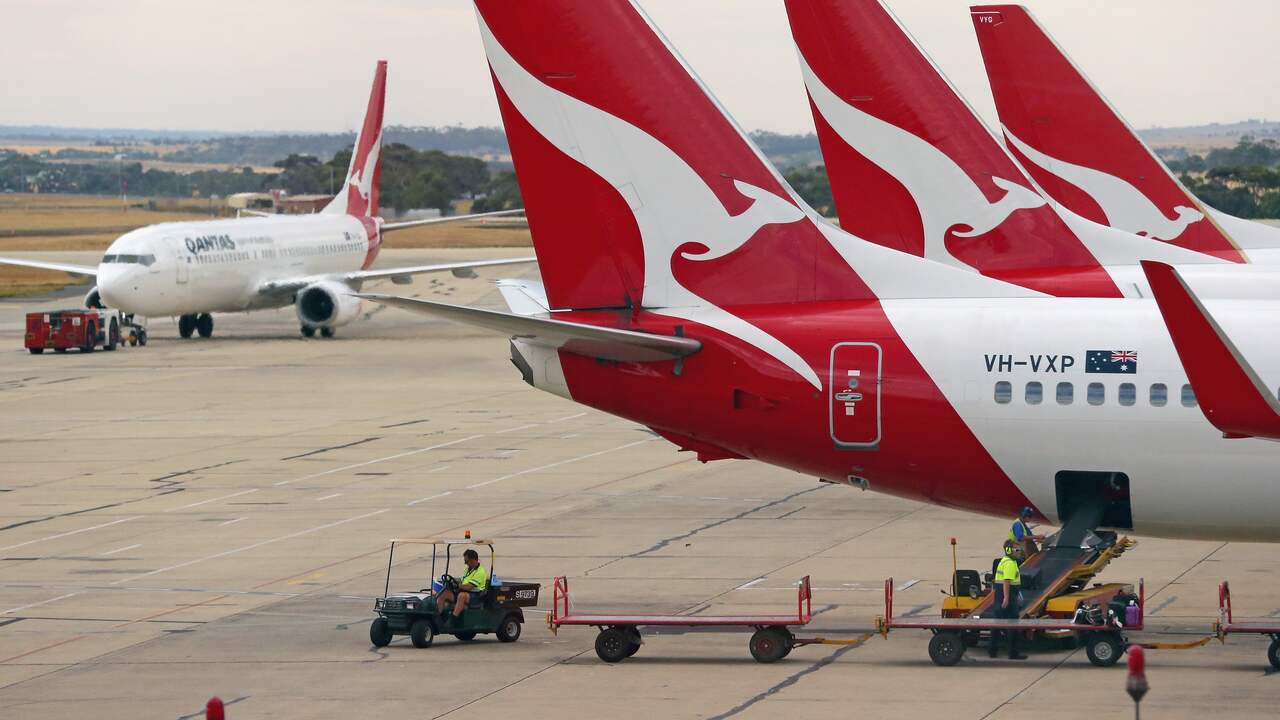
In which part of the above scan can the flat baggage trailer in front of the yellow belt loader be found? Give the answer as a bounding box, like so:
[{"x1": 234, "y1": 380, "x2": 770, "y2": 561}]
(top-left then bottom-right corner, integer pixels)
[{"x1": 876, "y1": 578, "x2": 1147, "y2": 667}]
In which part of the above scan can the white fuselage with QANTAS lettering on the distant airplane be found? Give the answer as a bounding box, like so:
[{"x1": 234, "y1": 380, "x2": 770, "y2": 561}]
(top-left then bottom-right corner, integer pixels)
[{"x1": 97, "y1": 214, "x2": 379, "y2": 316}]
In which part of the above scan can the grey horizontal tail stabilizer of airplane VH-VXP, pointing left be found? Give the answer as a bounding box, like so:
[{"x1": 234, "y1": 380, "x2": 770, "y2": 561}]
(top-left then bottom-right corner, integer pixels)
[{"x1": 355, "y1": 293, "x2": 703, "y2": 363}]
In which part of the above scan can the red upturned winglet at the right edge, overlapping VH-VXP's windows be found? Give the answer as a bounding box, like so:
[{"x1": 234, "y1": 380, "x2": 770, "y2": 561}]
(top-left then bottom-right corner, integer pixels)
[{"x1": 1142, "y1": 260, "x2": 1280, "y2": 439}]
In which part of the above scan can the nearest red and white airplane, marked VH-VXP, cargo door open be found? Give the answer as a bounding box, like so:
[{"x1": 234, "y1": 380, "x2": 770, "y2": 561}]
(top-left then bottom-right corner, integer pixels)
[{"x1": 365, "y1": 0, "x2": 1280, "y2": 541}]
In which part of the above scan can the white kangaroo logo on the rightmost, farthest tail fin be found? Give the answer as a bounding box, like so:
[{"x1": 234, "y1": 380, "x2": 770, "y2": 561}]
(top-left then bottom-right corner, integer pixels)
[{"x1": 1005, "y1": 126, "x2": 1204, "y2": 242}]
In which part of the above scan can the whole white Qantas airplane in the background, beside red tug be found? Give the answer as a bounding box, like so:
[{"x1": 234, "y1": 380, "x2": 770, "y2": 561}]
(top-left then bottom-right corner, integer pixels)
[{"x1": 0, "y1": 60, "x2": 534, "y2": 338}]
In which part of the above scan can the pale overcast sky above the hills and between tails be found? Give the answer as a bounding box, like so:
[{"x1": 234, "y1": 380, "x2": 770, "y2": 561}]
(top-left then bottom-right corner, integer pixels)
[{"x1": 0, "y1": 0, "x2": 1280, "y2": 132}]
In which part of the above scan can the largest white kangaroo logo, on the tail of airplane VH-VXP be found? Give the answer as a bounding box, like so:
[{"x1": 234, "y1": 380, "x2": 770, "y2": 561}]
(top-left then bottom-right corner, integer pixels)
[{"x1": 479, "y1": 17, "x2": 822, "y2": 389}]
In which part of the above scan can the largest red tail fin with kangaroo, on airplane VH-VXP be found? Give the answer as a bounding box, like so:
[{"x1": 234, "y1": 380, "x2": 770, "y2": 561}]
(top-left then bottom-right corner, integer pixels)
[{"x1": 476, "y1": 0, "x2": 1028, "y2": 316}]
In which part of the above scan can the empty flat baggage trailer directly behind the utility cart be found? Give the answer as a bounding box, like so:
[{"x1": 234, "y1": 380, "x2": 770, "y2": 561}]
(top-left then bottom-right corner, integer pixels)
[{"x1": 547, "y1": 575, "x2": 855, "y2": 662}]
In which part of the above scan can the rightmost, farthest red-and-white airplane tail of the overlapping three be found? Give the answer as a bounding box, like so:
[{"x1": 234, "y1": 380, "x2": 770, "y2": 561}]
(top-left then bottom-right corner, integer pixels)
[{"x1": 970, "y1": 5, "x2": 1280, "y2": 264}]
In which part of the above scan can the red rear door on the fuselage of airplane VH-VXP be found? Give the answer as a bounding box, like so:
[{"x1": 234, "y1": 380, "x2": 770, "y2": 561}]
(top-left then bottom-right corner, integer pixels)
[{"x1": 827, "y1": 342, "x2": 881, "y2": 450}]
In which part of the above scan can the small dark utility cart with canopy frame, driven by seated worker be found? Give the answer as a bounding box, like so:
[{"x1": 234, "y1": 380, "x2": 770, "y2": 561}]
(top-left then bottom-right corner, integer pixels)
[{"x1": 369, "y1": 533, "x2": 541, "y2": 648}]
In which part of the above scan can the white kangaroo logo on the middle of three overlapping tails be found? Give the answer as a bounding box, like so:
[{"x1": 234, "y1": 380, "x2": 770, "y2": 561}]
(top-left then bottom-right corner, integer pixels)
[{"x1": 800, "y1": 53, "x2": 1046, "y2": 268}]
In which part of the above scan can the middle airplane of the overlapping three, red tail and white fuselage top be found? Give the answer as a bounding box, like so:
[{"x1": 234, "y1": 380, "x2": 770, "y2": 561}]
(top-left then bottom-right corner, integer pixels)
[{"x1": 786, "y1": 0, "x2": 1280, "y2": 299}]
